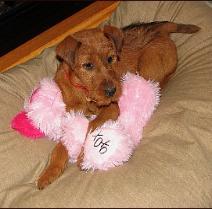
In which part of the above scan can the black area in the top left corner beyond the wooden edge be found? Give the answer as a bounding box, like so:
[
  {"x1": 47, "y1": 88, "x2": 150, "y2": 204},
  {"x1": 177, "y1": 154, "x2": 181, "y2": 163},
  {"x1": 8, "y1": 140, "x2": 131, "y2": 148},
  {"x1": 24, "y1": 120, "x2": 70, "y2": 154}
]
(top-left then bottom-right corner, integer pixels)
[{"x1": 0, "y1": 0, "x2": 94, "y2": 56}]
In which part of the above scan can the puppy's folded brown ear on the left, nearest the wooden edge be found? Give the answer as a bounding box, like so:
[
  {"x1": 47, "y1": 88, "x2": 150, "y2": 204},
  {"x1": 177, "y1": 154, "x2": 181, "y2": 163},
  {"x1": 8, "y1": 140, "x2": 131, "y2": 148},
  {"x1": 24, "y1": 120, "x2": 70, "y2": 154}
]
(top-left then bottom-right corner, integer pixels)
[{"x1": 56, "y1": 36, "x2": 81, "y2": 67}]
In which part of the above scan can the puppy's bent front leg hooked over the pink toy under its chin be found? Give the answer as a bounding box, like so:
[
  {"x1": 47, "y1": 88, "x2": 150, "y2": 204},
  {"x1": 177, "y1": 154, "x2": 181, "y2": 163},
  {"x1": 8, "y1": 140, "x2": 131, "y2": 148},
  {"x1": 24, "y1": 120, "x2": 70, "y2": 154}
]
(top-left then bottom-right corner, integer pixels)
[{"x1": 77, "y1": 103, "x2": 120, "y2": 169}]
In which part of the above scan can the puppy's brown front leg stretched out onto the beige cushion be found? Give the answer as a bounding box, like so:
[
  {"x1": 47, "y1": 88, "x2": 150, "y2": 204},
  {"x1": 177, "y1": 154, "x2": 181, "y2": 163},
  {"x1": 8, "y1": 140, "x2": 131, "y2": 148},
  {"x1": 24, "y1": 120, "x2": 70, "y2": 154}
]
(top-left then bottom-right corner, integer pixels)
[{"x1": 37, "y1": 143, "x2": 68, "y2": 189}]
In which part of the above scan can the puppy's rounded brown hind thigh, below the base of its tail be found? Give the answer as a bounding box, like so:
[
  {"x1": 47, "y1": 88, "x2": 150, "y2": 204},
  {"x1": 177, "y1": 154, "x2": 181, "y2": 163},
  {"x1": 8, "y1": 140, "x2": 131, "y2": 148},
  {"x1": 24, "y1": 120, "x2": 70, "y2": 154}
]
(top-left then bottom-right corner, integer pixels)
[{"x1": 138, "y1": 37, "x2": 177, "y2": 87}]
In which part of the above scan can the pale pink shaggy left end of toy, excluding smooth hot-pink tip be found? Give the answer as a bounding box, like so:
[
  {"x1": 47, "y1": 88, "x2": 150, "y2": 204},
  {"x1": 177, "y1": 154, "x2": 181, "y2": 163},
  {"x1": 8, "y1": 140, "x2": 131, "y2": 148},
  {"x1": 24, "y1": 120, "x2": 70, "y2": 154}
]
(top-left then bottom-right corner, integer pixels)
[{"x1": 24, "y1": 78, "x2": 65, "y2": 141}]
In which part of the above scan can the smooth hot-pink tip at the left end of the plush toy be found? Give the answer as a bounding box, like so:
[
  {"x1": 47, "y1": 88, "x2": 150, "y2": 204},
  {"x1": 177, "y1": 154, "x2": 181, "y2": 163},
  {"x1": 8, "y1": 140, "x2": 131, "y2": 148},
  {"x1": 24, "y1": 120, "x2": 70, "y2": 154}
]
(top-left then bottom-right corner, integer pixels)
[{"x1": 11, "y1": 111, "x2": 45, "y2": 140}]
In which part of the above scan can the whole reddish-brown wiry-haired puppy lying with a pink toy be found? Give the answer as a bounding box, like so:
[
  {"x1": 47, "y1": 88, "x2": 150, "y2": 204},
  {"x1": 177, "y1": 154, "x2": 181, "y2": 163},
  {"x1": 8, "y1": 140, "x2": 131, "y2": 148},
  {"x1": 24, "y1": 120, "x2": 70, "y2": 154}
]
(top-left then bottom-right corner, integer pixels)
[{"x1": 38, "y1": 22, "x2": 200, "y2": 189}]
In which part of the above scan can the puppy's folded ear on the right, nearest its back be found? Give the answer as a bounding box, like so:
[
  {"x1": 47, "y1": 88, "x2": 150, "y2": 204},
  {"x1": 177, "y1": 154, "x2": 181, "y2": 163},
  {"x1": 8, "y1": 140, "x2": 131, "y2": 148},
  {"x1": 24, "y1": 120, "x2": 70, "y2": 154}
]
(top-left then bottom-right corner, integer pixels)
[{"x1": 103, "y1": 25, "x2": 124, "y2": 55}]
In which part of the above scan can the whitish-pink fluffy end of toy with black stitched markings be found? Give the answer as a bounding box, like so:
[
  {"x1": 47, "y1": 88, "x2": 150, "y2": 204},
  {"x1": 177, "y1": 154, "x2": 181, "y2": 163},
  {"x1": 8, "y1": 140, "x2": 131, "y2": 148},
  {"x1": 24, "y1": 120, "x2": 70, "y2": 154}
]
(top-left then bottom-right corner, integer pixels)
[{"x1": 82, "y1": 121, "x2": 133, "y2": 170}]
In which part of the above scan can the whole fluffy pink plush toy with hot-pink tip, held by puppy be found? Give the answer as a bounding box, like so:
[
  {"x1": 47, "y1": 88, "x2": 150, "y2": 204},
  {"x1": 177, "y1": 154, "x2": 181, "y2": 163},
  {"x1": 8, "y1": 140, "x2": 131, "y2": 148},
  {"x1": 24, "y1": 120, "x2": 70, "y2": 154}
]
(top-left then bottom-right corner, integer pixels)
[{"x1": 11, "y1": 73, "x2": 160, "y2": 170}]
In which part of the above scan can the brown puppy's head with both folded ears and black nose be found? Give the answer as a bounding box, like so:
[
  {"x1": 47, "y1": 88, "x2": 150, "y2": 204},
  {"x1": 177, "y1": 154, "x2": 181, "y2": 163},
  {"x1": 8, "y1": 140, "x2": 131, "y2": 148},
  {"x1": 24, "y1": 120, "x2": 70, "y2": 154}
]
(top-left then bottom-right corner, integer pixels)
[{"x1": 56, "y1": 26, "x2": 123, "y2": 106}]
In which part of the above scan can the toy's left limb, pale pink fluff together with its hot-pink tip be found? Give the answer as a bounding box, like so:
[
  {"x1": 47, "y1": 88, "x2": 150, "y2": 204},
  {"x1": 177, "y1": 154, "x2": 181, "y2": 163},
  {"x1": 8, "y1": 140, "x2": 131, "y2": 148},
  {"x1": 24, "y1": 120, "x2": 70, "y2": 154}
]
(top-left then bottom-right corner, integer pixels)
[{"x1": 11, "y1": 78, "x2": 65, "y2": 140}]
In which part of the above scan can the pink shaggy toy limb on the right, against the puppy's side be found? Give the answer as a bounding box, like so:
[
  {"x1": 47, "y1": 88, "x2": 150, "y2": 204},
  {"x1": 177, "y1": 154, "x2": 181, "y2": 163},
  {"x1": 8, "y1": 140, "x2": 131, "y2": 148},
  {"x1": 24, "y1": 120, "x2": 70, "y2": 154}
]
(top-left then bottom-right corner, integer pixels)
[{"x1": 118, "y1": 73, "x2": 160, "y2": 146}]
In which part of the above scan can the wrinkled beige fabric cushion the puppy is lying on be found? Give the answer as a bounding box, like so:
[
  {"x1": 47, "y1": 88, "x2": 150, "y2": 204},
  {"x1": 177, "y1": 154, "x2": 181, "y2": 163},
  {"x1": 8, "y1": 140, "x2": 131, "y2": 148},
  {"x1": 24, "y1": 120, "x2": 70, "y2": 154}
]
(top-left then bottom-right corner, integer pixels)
[{"x1": 0, "y1": 1, "x2": 212, "y2": 207}]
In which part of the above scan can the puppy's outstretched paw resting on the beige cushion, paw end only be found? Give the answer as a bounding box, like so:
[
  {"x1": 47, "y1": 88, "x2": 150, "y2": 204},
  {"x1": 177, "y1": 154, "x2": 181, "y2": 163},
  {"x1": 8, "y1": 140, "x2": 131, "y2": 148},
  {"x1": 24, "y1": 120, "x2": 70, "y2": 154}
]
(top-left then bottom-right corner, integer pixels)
[{"x1": 37, "y1": 167, "x2": 62, "y2": 190}]
